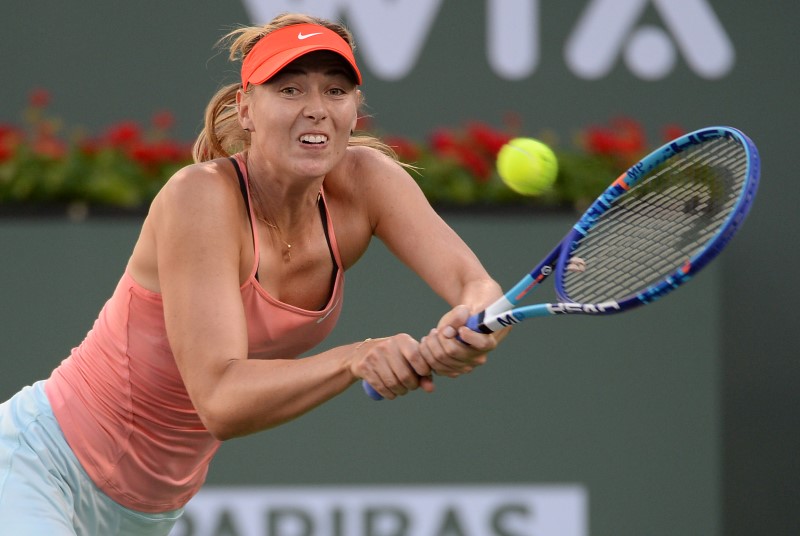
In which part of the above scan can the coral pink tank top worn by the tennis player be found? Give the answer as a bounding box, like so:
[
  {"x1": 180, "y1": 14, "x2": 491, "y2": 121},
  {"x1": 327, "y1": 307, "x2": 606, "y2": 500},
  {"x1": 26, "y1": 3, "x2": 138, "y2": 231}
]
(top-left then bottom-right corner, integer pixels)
[{"x1": 46, "y1": 157, "x2": 344, "y2": 512}]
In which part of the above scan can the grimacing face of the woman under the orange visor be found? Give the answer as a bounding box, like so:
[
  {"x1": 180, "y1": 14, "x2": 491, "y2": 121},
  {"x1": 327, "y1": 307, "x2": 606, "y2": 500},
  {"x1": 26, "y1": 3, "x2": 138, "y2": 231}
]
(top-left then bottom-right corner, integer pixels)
[{"x1": 238, "y1": 51, "x2": 360, "y2": 177}]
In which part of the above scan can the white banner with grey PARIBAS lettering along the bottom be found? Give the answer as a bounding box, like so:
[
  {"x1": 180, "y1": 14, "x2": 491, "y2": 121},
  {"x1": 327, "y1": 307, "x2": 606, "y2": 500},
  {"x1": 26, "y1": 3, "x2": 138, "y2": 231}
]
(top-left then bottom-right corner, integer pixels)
[{"x1": 170, "y1": 484, "x2": 589, "y2": 536}]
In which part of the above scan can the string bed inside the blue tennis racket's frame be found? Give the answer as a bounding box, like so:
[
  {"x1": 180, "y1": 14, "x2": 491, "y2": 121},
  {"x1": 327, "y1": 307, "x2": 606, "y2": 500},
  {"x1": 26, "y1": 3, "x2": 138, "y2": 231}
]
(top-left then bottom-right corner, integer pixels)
[{"x1": 563, "y1": 138, "x2": 747, "y2": 303}]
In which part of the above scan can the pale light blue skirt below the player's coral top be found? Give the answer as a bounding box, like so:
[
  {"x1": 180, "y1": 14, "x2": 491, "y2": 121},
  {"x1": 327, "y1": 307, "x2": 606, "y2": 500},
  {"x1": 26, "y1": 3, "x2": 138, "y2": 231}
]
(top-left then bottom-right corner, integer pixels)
[{"x1": 0, "y1": 381, "x2": 183, "y2": 536}]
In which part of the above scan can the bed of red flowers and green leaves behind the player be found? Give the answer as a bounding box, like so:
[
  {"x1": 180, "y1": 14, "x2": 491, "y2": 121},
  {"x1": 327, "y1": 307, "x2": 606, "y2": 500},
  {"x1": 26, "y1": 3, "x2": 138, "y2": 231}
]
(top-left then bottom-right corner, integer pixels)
[{"x1": 0, "y1": 90, "x2": 681, "y2": 213}]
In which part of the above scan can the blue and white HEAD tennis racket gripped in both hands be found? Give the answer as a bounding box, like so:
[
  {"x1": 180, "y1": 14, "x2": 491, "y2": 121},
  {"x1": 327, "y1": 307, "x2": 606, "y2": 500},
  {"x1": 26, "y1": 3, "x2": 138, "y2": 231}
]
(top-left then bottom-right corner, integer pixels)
[{"x1": 364, "y1": 127, "x2": 761, "y2": 400}]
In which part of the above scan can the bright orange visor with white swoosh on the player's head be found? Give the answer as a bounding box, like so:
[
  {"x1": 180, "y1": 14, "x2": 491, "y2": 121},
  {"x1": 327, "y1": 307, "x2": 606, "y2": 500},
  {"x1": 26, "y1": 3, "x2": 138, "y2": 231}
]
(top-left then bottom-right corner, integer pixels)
[{"x1": 242, "y1": 24, "x2": 361, "y2": 90}]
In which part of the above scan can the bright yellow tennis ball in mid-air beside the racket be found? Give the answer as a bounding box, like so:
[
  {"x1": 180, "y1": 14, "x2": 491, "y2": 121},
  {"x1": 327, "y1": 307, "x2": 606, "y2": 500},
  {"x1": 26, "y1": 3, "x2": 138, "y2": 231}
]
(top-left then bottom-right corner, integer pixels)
[{"x1": 497, "y1": 138, "x2": 558, "y2": 195}]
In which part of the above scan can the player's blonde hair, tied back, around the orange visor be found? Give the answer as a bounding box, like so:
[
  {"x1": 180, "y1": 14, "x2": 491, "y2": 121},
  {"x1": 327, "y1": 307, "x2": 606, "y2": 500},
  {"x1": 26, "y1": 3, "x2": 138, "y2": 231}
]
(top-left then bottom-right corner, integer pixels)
[{"x1": 192, "y1": 13, "x2": 398, "y2": 162}]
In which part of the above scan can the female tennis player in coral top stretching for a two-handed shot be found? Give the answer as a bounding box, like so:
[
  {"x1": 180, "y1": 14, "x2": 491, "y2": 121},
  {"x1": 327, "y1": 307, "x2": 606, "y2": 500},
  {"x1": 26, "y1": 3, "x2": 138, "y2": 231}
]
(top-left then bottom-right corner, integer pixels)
[{"x1": 0, "y1": 15, "x2": 502, "y2": 536}]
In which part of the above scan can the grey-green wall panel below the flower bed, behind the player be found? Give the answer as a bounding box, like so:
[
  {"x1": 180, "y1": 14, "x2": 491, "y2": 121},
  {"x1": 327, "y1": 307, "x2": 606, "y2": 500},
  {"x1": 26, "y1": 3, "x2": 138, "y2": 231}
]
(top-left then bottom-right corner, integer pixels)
[{"x1": 0, "y1": 214, "x2": 721, "y2": 536}]
